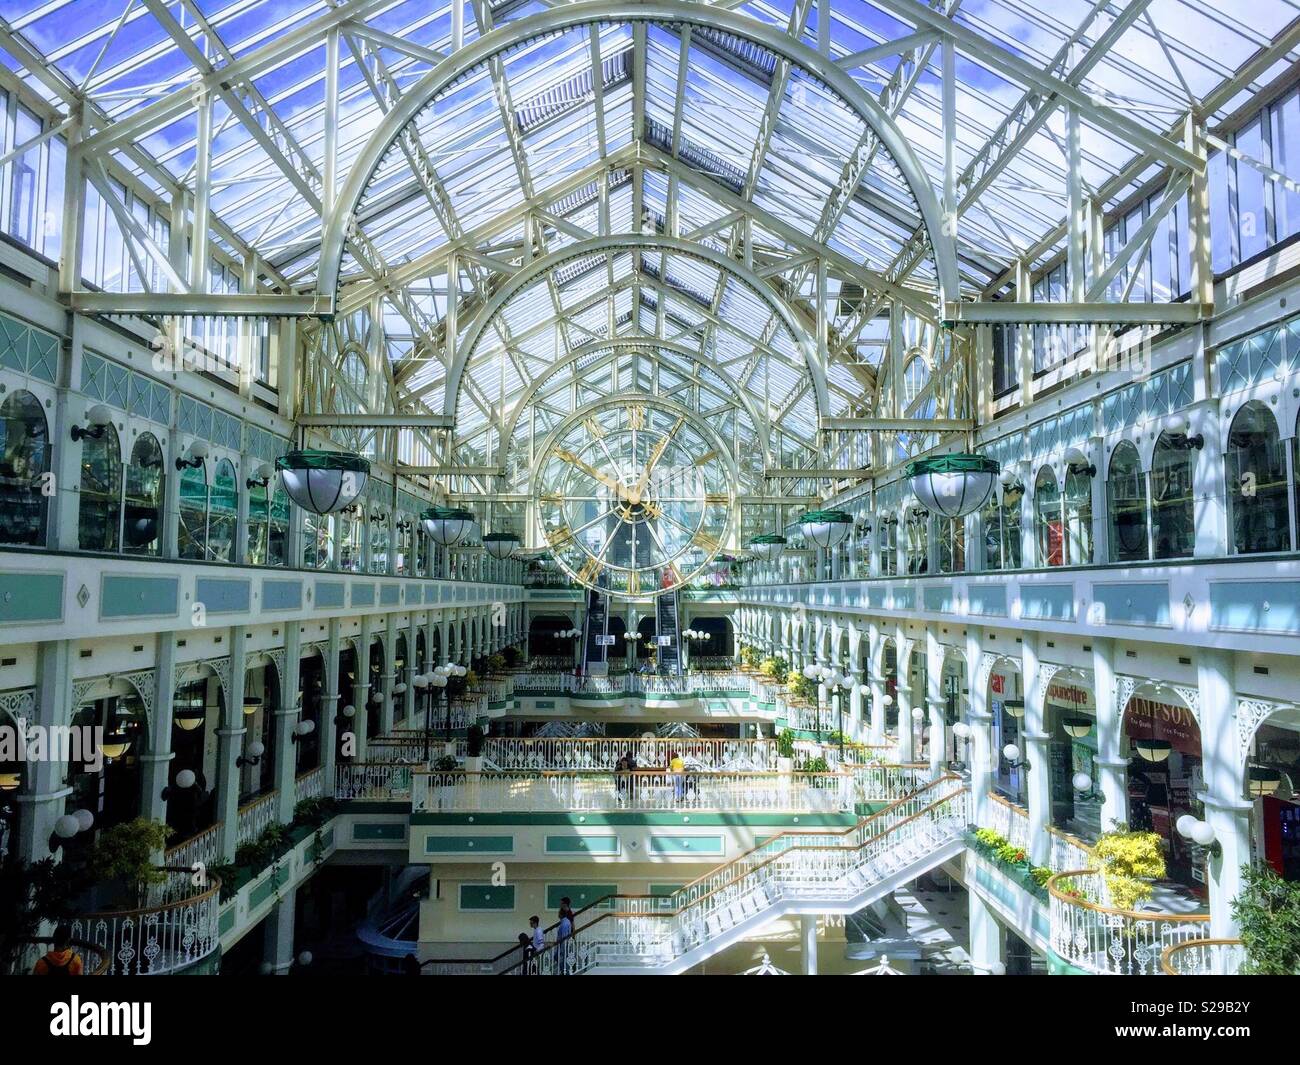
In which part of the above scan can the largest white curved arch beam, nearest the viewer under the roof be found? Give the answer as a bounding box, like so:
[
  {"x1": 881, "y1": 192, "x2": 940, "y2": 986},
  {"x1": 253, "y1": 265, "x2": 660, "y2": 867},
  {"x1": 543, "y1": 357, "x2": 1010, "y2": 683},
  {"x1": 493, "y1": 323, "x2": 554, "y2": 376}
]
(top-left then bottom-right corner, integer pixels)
[{"x1": 316, "y1": 0, "x2": 959, "y2": 306}]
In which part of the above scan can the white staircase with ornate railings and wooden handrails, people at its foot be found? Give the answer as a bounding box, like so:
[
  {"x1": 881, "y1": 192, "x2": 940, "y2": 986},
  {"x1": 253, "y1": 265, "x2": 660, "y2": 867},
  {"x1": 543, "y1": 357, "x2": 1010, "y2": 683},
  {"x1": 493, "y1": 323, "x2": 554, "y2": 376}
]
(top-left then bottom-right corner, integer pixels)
[{"x1": 510, "y1": 776, "x2": 969, "y2": 975}]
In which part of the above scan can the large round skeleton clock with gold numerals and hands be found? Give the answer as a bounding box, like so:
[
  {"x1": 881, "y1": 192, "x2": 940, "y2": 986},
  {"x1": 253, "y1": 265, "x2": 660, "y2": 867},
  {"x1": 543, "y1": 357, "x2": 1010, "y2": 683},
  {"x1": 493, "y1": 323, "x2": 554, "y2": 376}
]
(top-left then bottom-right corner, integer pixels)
[{"x1": 533, "y1": 395, "x2": 735, "y2": 597}]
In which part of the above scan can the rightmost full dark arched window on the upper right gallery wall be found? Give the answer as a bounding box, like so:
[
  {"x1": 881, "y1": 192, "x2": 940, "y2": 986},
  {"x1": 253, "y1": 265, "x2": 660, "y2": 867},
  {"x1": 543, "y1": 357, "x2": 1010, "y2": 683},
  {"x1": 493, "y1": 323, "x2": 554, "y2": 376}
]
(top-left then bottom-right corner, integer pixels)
[{"x1": 1223, "y1": 401, "x2": 1291, "y2": 554}]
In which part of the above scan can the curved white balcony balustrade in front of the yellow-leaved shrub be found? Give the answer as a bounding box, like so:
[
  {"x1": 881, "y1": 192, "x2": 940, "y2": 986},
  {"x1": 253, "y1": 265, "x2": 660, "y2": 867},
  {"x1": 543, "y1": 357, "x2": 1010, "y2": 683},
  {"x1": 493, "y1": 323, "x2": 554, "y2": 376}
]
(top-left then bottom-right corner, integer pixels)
[{"x1": 1048, "y1": 869, "x2": 1209, "y2": 977}]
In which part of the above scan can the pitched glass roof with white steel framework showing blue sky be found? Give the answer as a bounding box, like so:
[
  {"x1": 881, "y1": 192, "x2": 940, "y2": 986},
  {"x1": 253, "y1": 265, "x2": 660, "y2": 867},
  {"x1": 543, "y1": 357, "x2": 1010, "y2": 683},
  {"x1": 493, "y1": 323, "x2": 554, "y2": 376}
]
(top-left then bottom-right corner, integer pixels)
[{"x1": 0, "y1": 0, "x2": 1296, "y2": 462}]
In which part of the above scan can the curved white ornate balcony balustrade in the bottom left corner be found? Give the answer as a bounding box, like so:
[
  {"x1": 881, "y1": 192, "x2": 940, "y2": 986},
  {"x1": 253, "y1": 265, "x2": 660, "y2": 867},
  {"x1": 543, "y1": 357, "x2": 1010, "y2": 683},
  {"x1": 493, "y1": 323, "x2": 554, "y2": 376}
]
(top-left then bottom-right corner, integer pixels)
[{"x1": 69, "y1": 867, "x2": 221, "y2": 977}]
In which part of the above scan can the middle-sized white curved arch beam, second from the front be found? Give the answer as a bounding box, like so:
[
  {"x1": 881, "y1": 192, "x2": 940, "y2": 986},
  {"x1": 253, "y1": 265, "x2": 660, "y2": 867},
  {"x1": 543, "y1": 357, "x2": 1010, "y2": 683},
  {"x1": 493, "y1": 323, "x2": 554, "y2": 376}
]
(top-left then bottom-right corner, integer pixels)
[{"x1": 443, "y1": 233, "x2": 829, "y2": 417}]
